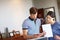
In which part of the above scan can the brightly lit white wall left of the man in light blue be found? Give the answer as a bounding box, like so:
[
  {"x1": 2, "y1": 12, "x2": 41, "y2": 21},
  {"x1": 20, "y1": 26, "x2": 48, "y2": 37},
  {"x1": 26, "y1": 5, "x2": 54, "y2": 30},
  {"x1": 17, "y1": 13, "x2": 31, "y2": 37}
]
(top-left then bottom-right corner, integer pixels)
[{"x1": 0, "y1": 0, "x2": 33, "y2": 33}]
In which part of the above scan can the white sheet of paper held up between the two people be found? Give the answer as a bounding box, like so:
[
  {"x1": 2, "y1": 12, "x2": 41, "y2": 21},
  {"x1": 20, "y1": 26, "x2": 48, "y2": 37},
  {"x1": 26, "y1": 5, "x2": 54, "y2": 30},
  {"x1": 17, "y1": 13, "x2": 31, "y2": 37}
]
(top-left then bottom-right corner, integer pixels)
[{"x1": 42, "y1": 24, "x2": 53, "y2": 37}]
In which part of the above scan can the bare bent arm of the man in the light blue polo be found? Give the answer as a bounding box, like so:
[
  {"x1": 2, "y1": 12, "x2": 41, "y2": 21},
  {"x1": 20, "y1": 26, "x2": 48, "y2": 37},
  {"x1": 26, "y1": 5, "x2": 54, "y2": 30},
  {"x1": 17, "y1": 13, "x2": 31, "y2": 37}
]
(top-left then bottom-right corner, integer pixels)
[{"x1": 23, "y1": 30, "x2": 45, "y2": 39}]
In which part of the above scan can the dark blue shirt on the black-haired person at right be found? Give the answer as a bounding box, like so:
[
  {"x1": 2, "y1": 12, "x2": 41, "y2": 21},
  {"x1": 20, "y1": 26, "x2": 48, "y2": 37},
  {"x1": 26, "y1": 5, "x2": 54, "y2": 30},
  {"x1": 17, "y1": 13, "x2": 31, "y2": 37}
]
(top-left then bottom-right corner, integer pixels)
[{"x1": 49, "y1": 22, "x2": 60, "y2": 40}]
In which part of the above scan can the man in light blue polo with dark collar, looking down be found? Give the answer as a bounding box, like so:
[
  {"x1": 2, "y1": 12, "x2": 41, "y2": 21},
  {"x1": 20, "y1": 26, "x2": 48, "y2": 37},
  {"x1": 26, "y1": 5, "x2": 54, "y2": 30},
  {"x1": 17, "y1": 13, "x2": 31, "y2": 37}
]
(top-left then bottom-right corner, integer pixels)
[{"x1": 22, "y1": 7, "x2": 45, "y2": 39}]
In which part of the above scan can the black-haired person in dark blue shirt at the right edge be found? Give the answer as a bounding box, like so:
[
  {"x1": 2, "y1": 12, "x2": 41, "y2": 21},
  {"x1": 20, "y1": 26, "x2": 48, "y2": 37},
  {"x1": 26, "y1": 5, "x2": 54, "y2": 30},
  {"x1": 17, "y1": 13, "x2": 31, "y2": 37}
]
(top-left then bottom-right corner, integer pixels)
[{"x1": 46, "y1": 11, "x2": 60, "y2": 40}]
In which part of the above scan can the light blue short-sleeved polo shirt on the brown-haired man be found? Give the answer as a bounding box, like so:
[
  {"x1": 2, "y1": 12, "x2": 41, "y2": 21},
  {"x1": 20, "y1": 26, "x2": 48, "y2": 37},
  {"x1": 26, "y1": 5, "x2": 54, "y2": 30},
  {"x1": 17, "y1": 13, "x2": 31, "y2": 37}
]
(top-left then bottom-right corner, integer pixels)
[{"x1": 22, "y1": 18, "x2": 41, "y2": 35}]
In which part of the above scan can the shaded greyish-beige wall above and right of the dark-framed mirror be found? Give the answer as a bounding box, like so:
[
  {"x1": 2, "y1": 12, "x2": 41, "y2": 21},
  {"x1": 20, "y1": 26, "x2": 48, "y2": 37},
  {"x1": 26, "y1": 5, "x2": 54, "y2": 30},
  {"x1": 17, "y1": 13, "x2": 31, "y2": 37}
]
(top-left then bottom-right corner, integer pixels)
[{"x1": 33, "y1": 0, "x2": 59, "y2": 22}]
